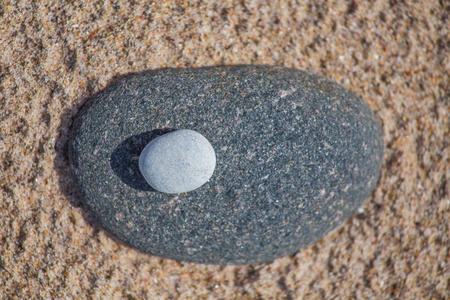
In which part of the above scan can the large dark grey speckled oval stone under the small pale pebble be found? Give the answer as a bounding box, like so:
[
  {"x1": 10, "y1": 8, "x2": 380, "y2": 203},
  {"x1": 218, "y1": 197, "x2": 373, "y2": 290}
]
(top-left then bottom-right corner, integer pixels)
[{"x1": 70, "y1": 66, "x2": 383, "y2": 264}]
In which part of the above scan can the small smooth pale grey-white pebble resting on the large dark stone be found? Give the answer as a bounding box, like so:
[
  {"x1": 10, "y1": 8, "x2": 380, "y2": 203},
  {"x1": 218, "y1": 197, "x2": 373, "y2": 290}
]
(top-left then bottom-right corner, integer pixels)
[{"x1": 139, "y1": 129, "x2": 216, "y2": 194}]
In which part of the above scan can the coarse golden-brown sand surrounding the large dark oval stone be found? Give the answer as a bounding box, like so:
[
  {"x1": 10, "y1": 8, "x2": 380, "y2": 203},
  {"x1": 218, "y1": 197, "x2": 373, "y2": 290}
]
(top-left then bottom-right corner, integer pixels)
[{"x1": 0, "y1": 0, "x2": 450, "y2": 299}]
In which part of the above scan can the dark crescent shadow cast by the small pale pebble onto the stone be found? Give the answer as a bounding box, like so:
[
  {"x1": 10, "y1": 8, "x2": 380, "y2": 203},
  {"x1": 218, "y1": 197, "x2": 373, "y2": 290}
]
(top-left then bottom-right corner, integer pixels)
[{"x1": 110, "y1": 128, "x2": 175, "y2": 192}]
